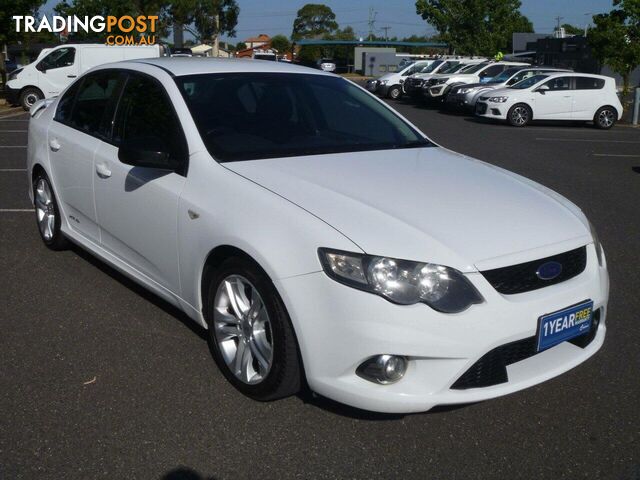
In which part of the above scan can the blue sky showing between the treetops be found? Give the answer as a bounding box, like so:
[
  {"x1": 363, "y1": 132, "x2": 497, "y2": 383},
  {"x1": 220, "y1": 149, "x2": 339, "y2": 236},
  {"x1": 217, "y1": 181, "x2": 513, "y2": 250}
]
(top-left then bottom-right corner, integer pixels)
[{"x1": 43, "y1": 0, "x2": 612, "y2": 42}]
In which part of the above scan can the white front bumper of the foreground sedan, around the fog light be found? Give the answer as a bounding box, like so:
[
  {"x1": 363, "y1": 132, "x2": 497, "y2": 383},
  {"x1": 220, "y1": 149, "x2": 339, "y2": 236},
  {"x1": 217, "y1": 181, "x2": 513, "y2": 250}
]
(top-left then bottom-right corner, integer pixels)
[{"x1": 276, "y1": 245, "x2": 609, "y2": 413}]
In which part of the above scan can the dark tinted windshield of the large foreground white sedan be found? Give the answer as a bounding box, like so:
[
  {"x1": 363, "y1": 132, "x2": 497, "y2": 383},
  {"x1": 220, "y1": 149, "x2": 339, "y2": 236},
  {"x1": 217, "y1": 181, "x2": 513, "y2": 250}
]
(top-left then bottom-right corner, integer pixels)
[{"x1": 176, "y1": 72, "x2": 432, "y2": 162}]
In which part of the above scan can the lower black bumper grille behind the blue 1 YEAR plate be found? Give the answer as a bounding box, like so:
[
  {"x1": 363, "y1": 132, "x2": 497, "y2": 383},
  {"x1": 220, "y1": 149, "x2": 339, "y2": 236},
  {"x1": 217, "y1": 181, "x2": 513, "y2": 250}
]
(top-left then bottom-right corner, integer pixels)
[{"x1": 451, "y1": 309, "x2": 601, "y2": 390}]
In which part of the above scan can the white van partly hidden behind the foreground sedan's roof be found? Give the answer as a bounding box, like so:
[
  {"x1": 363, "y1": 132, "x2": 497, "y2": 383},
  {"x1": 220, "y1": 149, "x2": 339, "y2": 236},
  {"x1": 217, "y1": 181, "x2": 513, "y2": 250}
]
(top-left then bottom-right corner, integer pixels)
[{"x1": 6, "y1": 44, "x2": 161, "y2": 110}]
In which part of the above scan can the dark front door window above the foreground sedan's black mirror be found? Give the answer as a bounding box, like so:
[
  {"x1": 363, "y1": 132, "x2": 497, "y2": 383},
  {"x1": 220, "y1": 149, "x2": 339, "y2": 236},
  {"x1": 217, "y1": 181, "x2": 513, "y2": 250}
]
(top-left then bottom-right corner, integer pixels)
[{"x1": 113, "y1": 75, "x2": 187, "y2": 168}]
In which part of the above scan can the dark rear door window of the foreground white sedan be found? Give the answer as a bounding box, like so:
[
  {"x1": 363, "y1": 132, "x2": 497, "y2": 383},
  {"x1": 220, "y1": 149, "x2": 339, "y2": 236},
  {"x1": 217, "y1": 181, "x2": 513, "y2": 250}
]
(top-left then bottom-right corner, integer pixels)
[{"x1": 70, "y1": 70, "x2": 123, "y2": 137}]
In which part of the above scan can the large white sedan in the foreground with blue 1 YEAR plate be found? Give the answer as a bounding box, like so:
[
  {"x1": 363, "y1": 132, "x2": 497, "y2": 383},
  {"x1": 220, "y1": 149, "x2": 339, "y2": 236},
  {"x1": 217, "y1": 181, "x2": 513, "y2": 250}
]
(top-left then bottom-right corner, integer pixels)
[{"x1": 28, "y1": 58, "x2": 609, "y2": 412}]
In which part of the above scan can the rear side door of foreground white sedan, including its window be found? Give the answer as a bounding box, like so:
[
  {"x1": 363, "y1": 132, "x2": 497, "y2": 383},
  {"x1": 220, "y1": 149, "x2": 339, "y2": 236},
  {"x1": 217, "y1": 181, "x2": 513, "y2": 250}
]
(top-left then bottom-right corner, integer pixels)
[{"x1": 47, "y1": 70, "x2": 123, "y2": 243}]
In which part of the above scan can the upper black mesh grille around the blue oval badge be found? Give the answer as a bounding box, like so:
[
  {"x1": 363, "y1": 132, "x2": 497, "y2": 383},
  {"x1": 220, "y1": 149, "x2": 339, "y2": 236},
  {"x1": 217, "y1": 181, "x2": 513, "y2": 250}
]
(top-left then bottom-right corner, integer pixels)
[{"x1": 478, "y1": 248, "x2": 587, "y2": 295}]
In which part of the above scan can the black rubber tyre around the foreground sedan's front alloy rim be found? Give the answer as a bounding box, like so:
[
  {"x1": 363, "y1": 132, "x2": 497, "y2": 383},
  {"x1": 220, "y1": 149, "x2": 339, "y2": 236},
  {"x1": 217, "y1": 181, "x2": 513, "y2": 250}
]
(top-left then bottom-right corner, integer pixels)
[{"x1": 205, "y1": 257, "x2": 303, "y2": 401}]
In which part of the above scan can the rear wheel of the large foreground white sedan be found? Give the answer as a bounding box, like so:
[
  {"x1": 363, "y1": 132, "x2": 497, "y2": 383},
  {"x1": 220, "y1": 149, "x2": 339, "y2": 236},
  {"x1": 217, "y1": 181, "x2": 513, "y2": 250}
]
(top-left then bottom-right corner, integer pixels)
[{"x1": 33, "y1": 171, "x2": 69, "y2": 250}]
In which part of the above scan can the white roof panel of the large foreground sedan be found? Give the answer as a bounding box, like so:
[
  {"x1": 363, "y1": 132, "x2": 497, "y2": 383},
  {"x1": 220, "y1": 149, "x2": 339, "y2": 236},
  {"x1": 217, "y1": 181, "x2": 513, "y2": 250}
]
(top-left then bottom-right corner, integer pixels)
[{"x1": 122, "y1": 57, "x2": 332, "y2": 77}]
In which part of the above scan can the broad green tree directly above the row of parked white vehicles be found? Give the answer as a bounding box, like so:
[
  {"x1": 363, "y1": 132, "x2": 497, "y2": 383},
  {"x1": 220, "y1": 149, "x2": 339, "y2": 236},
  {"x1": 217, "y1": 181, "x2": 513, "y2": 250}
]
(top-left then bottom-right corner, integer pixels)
[{"x1": 416, "y1": 0, "x2": 533, "y2": 56}]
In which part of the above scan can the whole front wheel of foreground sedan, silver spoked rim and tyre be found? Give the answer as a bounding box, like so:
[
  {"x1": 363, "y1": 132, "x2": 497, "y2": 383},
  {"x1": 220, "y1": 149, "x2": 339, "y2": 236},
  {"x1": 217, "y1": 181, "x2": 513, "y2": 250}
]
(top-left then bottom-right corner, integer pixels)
[{"x1": 206, "y1": 257, "x2": 302, "y2": 401}]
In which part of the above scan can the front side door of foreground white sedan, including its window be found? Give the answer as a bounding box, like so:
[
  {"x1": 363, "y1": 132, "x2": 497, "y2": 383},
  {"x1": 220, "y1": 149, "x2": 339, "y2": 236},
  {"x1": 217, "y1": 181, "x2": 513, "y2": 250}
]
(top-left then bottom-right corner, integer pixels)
[{"x1": 94, "y1": 73, "x2": 188, "y2": 294}]
